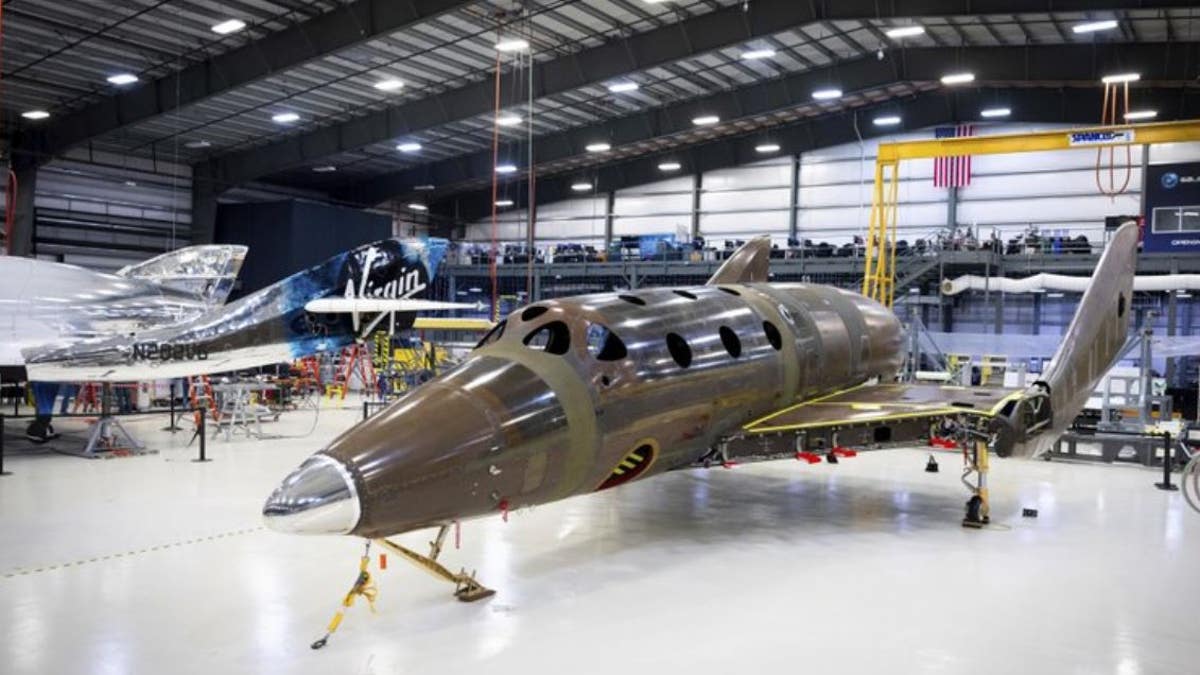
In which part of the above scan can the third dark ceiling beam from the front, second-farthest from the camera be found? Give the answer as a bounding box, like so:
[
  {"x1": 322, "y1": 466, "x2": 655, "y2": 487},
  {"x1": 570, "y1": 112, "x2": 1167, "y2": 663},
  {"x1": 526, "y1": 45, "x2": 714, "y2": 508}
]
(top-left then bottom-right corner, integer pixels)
[{"x1": 331, "y1": 43, "x2": 1200, "y2": 207}]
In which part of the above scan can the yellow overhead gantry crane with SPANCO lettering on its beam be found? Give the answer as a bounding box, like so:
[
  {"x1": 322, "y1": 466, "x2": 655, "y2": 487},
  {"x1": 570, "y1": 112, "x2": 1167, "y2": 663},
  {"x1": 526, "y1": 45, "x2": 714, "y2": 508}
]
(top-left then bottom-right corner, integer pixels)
[{"x1": 863, "y1": 120, "x2": 1200, "y2": 307}]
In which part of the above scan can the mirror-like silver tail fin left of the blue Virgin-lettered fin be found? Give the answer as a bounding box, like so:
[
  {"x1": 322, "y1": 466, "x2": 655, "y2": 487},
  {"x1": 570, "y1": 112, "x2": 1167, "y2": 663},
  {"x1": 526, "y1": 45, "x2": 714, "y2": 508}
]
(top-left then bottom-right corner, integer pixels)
[{"x1": 116, "y1": 244, "x2": 246, "y2": 305}]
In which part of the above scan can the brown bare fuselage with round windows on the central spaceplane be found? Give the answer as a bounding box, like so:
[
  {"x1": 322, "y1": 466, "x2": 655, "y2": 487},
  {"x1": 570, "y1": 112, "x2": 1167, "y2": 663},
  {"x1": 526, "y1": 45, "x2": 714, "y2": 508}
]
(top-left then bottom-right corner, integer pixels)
[{"x1": 268, "y1": 278, "x2": 901, "y2": 537}]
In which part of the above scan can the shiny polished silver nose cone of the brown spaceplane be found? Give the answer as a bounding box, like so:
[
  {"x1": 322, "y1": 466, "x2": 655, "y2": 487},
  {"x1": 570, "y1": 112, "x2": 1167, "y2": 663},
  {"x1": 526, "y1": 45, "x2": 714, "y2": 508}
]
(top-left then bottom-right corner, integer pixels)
[{"x1": 263, "y1": 455, "x2": 361, "y2": 534}]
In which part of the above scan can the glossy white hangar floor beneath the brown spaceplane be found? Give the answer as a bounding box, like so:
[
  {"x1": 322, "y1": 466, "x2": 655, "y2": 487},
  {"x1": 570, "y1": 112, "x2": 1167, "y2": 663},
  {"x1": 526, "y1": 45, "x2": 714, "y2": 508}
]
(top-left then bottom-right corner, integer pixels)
[{"x1": 0, "y1": 410, "x2": 1200, "y2": 675}]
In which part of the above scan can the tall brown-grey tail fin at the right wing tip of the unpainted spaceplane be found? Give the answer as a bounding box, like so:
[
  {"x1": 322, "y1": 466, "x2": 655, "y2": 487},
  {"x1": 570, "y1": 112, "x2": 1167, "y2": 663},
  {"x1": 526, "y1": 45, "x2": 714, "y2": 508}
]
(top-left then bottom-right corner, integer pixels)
[{"x1": 1014, "y1": 222, "x2": 1138, "y2": 454}]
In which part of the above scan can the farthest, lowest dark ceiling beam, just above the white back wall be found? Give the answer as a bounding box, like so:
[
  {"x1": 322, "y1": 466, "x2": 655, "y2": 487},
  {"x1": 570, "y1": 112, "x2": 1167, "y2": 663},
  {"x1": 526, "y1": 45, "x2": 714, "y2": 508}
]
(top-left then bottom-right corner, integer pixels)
[{"x1": 431, "y1": 86, "x2": 1200, "y2": 222}]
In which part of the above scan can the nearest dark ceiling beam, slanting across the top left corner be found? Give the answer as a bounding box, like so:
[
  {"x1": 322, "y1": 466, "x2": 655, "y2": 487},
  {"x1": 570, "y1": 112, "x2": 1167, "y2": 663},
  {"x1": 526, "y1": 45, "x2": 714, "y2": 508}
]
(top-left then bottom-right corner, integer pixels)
[{"x1": 31, "y1": 0, "x2": 475, "y2": 160}]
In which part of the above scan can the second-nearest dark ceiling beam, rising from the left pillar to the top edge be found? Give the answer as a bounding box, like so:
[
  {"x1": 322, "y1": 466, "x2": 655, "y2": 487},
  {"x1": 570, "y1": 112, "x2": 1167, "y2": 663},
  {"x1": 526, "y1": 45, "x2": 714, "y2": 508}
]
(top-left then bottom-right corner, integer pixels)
[{"x1": 201, "y1": 0, "x2": 1189, "y2": 187}]
